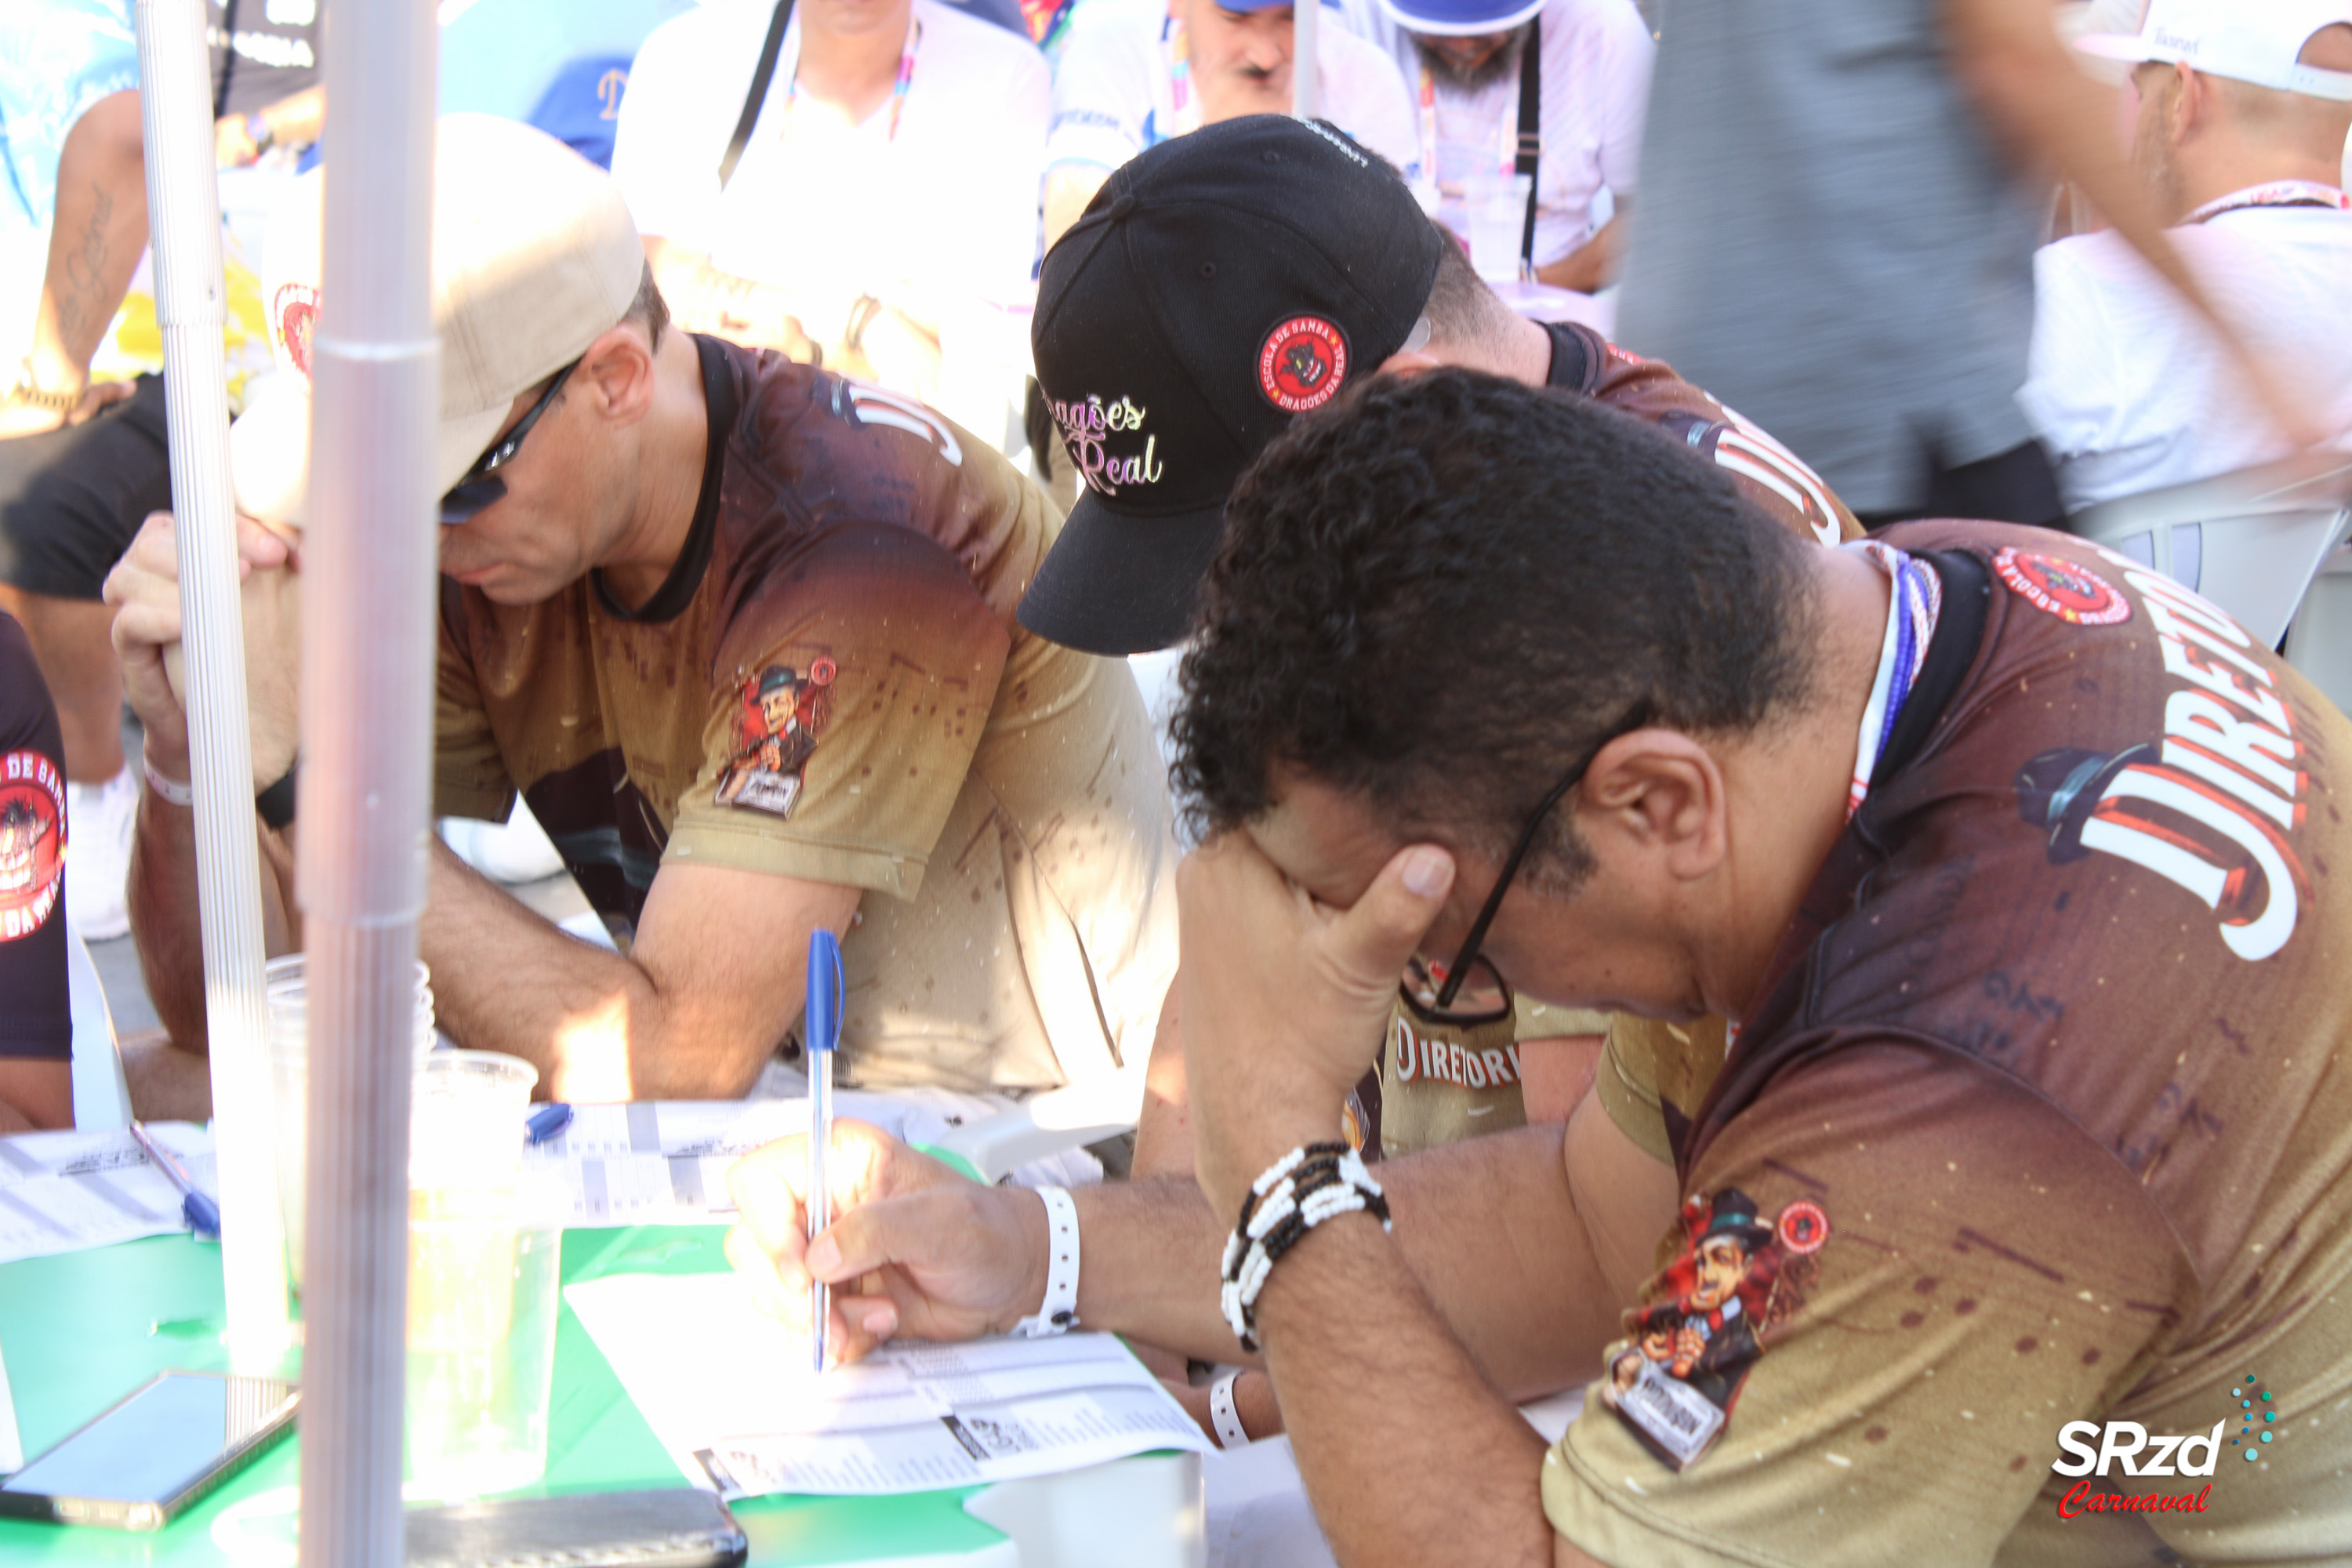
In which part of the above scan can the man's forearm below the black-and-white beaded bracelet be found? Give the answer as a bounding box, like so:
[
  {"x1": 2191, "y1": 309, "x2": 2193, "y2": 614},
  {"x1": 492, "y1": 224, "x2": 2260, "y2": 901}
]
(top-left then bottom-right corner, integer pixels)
[{"x1": 1258, "y1": 1213, "x2": 1552, "y2": 1568}]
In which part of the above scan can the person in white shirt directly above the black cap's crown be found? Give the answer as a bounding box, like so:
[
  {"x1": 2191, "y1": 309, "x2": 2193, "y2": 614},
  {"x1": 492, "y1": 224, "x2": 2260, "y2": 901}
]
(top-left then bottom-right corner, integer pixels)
[{"x1": 1044, "y1": 0, "x2": 1416, "y2": 245}]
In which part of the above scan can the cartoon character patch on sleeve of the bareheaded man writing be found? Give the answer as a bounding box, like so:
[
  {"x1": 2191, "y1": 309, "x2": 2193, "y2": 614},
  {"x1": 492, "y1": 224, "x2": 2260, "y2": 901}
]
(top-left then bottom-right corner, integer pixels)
[{"x1": 1602, "y1": 1187, "x2": 1830, "y2": 1469}]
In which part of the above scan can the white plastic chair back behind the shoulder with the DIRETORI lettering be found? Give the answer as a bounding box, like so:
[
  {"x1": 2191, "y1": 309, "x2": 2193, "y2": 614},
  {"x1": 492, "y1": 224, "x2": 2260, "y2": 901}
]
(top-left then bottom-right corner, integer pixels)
[{"x1": 2067, "y1": 452, "x2": 2352, "y2": 647}]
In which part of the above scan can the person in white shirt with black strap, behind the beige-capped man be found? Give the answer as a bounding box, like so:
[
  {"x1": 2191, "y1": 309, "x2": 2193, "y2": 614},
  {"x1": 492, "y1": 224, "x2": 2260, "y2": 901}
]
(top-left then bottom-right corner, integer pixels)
[{"x1": 612, "y1": 0, "x2": 1051, "y2": 397}]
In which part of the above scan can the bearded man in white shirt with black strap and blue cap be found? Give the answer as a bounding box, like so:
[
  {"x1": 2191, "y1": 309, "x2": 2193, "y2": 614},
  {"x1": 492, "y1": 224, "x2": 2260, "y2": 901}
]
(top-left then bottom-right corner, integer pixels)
[{"x1": 1348, "y1": 0, "x2": 1658, "y2": 294}]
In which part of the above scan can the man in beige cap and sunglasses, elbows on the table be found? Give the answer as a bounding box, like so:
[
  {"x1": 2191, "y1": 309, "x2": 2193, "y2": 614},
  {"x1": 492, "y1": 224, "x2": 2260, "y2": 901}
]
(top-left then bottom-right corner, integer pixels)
[{"x1": 108, "y1": 115, "x2": 1176, "y2": 1100}]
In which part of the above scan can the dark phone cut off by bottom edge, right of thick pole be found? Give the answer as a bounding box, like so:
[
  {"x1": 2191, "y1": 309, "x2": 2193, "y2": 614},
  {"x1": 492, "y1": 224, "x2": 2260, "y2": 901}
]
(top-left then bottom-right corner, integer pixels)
[{"x1": 407, "y1": 1486, "x2": 750, "y2": 1568}]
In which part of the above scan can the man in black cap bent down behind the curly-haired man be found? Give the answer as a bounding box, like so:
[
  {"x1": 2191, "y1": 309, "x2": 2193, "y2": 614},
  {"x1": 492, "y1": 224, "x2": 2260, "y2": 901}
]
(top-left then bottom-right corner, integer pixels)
[{"x1": 1021, "y1": 115, "x2": 1858, "y2": 1241}]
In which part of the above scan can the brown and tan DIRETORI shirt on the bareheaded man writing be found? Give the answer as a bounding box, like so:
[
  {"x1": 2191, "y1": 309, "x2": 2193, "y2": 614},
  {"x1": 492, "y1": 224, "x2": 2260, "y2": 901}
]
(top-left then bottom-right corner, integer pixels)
[{"x1": 1543, "y1": 522, "x2": 2352, "y2": 1568}]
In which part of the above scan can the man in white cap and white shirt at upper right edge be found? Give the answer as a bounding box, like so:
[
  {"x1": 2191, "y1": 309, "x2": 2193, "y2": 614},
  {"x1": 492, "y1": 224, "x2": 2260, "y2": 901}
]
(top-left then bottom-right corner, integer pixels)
[{"x1": 2020, "y1": 0, "x2": 2352, "y2": 510}]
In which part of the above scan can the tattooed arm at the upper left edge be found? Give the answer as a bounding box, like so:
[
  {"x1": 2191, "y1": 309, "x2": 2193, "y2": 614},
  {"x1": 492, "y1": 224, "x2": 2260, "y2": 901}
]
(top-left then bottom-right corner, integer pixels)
[{"x1": 0, "y1": 92, "x2": 146, "y2": 437}]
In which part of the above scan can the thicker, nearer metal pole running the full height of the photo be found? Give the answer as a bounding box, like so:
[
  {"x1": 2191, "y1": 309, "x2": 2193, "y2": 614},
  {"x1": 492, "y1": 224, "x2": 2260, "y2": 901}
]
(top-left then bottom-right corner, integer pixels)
[{"x1": 299, "y1": 0, "x2": 440, "y2": 1568}]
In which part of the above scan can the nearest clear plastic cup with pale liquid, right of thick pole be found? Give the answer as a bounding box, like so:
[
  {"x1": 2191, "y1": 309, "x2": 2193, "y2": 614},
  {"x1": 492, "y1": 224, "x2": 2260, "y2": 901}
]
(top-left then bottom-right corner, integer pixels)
[{"x1": 407, "y1": 1051, "x2": 564, "y2": 1500}]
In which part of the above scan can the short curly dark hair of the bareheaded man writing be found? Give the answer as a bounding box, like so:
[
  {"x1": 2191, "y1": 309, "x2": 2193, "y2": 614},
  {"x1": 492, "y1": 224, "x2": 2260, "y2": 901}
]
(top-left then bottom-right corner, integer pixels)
[{"x1": 1174, "y1": 369, "x2": 1813, "y2": 891}]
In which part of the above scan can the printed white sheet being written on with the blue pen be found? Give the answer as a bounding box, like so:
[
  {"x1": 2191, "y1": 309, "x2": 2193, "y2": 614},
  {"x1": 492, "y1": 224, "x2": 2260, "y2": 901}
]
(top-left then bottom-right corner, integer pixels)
[{"x1": 564, "y1": 1274, "x2": 1209, "y2": 1497}]
